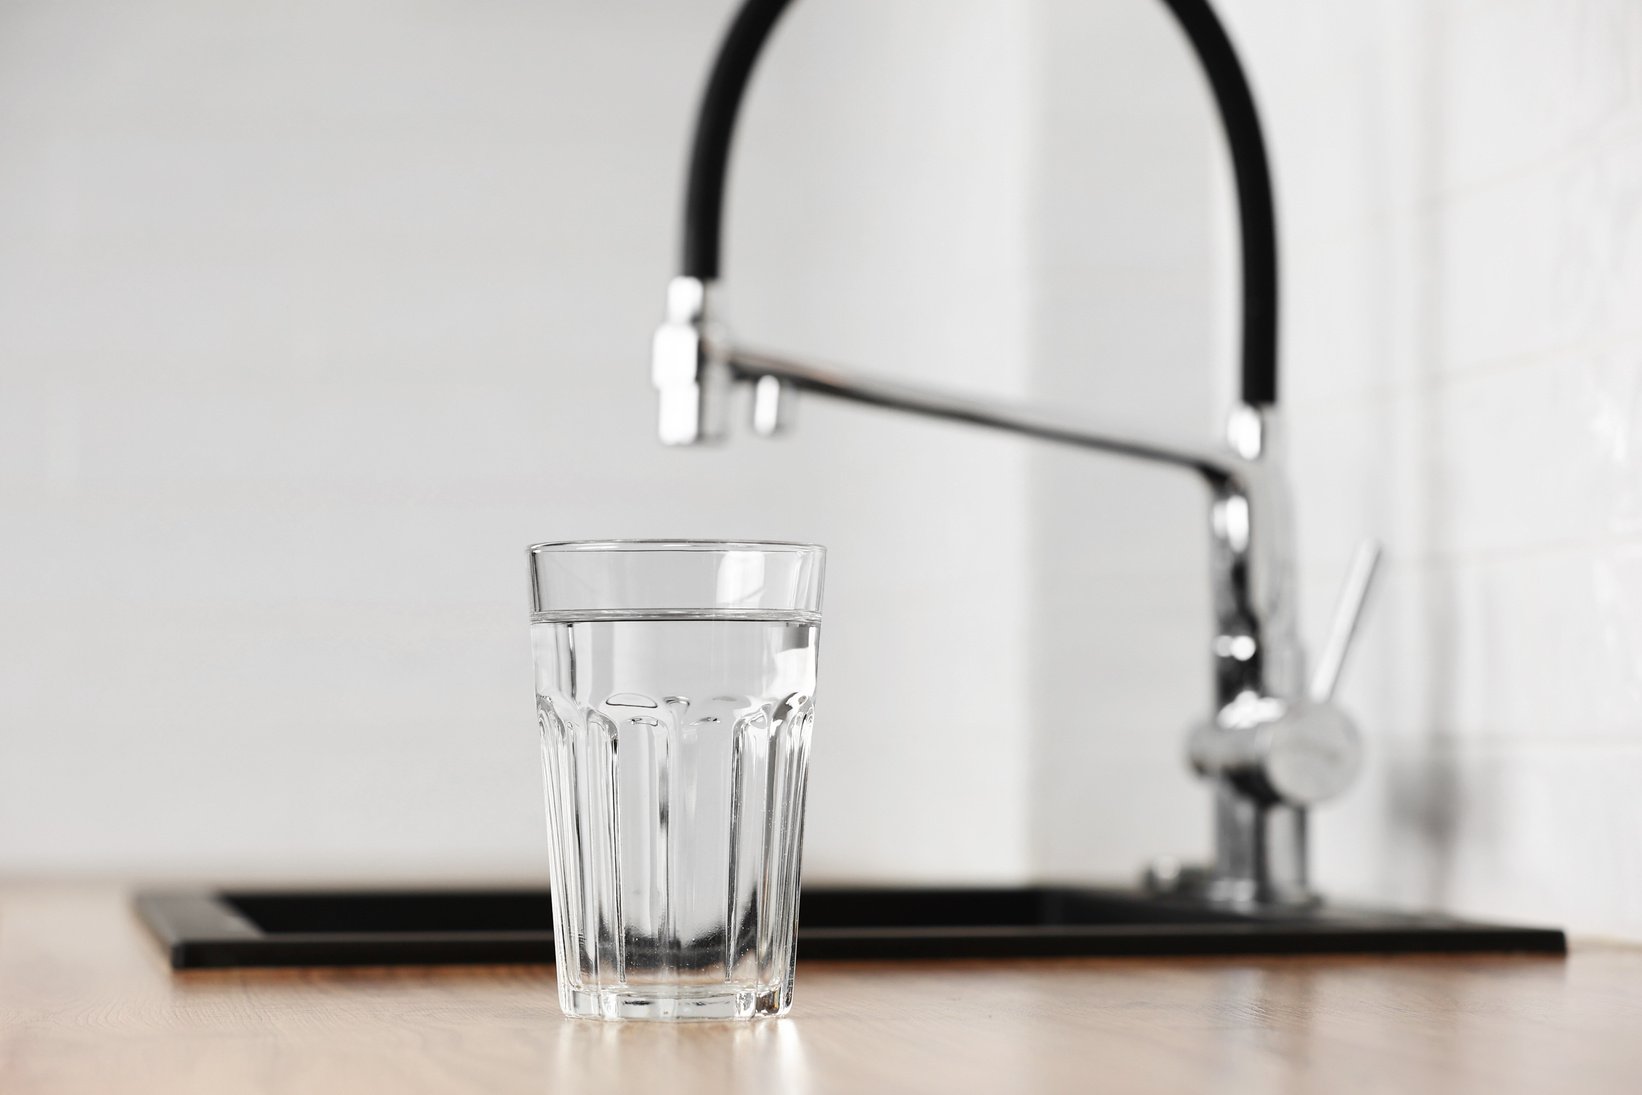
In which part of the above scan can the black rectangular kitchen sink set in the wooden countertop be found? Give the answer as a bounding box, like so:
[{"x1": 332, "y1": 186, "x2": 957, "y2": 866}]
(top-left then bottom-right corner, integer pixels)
[{"x1": 136, "y1": 887, "x2": 1566, "y2": 970}]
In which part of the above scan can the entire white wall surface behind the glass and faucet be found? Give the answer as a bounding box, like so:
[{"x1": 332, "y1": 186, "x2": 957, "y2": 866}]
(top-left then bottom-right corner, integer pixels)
[{"x1": 0, "y1": 0, "x2": 1642, "y2": 936}]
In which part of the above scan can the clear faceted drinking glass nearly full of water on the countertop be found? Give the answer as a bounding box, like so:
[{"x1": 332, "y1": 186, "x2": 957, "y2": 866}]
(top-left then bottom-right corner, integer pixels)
[{"x1": 530, "y1": 540, "x2": 826, "y2": 1019}]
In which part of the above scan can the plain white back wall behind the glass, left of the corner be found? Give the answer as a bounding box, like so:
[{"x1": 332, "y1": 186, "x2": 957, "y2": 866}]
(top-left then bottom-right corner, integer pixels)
[{"x1": 0, "y1": 0, "x2": 1028, "y2": 878}]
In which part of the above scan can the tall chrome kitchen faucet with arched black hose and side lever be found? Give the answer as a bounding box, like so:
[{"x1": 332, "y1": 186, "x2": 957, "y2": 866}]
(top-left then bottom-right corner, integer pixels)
[{"x1": 652, "y1": 0, "x2": 1379, "y2": 905}]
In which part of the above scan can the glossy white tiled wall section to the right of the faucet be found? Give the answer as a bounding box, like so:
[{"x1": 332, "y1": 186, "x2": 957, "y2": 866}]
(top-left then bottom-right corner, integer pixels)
[{"x1": 1227, "y1": 0, "x2": 1642, "y2": 936}]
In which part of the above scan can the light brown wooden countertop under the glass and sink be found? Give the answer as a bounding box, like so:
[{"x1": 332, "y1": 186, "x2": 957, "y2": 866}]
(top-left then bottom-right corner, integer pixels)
[{"x1": 0, "y1": 888, "x2": 1642, "y2": 1095}]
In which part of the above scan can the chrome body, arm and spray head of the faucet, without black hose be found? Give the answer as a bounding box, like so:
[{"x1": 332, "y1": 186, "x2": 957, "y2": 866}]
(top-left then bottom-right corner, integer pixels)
[{"x1": 652, "y1": 277, "x2": 1360, "y2": 905}]
